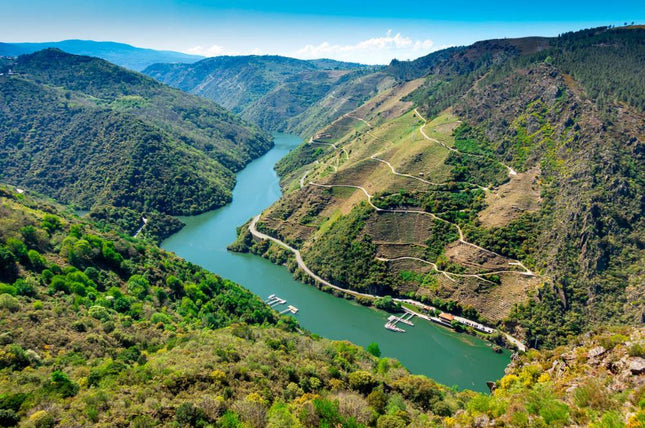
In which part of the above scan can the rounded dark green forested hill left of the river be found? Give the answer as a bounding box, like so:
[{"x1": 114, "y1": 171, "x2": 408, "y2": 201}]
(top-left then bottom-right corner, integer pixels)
[{"x1": 0, "y1": 50, "x2": 272, "y2": 214}]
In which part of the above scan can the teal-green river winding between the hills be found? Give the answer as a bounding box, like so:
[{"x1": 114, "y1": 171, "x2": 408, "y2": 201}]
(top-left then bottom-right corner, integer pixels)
[{"x1": 162, "y1": 134, "x2": 510, "y2": 392}]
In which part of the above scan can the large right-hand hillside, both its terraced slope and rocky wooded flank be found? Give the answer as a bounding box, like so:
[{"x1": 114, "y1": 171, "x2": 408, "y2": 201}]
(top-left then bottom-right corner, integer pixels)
[{"x1": 236, "y1": 28, "x2": 645, "y2": 347}]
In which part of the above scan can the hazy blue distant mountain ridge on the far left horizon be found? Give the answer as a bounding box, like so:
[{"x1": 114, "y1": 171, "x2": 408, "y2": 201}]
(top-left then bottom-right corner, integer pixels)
[{"x1": 0, "y1": 40, "x2": 204, "y2": 71}]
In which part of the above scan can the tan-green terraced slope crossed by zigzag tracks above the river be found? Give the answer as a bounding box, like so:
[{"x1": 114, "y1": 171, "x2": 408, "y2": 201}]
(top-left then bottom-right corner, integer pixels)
[{"x1": 262, "y1": 80, "x2": 538, "y2": 320}]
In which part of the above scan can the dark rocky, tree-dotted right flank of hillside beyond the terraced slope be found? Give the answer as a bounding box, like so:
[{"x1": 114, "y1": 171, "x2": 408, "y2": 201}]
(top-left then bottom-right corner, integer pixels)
[{"x1": 456, "y1": 29, "x2": 645, "y2": 346}]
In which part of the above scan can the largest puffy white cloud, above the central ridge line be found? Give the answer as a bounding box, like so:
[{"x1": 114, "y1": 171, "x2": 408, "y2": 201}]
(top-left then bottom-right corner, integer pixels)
[{"x1": 294, "y1": 30, "x2": 434, "y2": 64}]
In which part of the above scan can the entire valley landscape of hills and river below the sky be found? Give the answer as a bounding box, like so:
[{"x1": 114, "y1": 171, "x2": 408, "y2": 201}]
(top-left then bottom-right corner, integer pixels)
[{"x1": 0, "y1": 21, "x2": 645, "y2": 428}]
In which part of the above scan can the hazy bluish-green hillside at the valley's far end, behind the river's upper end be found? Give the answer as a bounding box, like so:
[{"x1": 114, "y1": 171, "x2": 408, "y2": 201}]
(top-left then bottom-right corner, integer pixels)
[{"x1": 144, "y1": 56, "x2": 372, "y2": 130}]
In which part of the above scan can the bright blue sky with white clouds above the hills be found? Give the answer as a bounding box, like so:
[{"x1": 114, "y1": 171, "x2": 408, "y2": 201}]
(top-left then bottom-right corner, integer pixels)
[{"x1": 0, "y1": 0, "x2": 645, "y2": 63}]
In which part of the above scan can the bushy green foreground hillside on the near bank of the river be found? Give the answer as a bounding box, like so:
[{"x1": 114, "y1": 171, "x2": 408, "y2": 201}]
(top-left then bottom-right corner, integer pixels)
[{"x1": 0, "y1": 186, "x2": 645, "y2": 427}]
